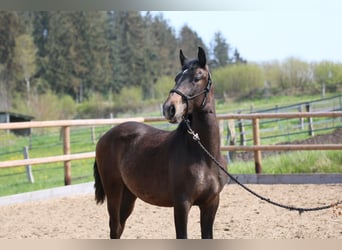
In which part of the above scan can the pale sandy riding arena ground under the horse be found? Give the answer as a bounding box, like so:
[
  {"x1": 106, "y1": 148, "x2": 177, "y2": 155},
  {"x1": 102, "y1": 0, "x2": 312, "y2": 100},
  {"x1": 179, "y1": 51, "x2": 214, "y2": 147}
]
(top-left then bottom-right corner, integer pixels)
[{"x1": 0, "y1": 185, "x2": 342, "y2": 239}]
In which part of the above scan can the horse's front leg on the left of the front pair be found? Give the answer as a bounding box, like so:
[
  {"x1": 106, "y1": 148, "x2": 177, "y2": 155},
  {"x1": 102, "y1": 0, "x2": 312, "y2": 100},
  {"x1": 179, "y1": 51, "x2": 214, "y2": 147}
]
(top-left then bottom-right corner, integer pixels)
[{"x1": 174, "y1": 200, "x2": 191, "y2": 239}]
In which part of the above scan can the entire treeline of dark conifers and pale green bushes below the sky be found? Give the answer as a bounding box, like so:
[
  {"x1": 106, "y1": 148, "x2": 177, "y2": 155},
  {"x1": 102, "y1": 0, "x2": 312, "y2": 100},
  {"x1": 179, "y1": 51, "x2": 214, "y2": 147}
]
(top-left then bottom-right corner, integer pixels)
[{"x1": 0, "y1": 11, "x2": 342, "y2": 120}]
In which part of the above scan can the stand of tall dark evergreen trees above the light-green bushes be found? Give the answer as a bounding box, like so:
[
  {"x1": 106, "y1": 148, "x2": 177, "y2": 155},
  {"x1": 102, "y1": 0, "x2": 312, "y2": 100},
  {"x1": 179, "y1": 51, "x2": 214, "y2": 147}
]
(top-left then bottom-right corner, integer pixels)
[{"x1": 0, "y1": 11, "x2": 256, "y2": 117}]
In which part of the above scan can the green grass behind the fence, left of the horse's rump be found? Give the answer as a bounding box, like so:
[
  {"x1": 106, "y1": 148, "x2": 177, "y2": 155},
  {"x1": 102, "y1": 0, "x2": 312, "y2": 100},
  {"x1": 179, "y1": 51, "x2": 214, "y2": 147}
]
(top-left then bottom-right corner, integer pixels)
[{"x1": 0, "y1": 126, "x2": 110, "y2": 196}]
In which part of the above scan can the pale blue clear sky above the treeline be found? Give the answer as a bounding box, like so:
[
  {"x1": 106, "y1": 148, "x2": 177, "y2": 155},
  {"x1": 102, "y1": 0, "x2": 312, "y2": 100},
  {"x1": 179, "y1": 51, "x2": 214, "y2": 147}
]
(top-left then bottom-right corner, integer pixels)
[{"x1": 152, "y1": 8, "x2": 342, "y2": 63}]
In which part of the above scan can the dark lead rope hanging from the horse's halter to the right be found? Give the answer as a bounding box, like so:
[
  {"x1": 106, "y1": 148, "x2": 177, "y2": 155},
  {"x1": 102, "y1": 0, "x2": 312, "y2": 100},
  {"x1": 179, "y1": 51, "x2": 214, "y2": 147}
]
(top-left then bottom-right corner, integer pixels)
[{"x1": 183, "y1": 117, "x2": 342, "y2": 214}]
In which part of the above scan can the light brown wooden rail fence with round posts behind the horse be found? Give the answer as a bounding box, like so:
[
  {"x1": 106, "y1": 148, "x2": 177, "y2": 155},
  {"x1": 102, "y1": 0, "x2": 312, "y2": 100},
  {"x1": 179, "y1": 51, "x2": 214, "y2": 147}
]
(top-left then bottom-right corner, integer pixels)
[{"x1": 0, "y1": 111, "x2": 342, "y2": 185}]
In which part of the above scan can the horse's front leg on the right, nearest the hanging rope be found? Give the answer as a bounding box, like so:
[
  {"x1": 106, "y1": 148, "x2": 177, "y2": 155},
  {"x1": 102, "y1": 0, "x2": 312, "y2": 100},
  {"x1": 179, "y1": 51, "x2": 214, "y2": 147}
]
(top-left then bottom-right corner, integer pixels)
[{"x1": 200, "y1": 195, "x2": 220, "y2": 239}]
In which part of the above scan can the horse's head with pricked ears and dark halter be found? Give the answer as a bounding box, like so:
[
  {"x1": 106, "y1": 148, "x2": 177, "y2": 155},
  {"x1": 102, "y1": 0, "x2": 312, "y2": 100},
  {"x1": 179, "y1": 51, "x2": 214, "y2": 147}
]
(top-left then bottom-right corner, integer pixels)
[{"x1": 163, "y1": 47, "x2": 211, "y2": 123}]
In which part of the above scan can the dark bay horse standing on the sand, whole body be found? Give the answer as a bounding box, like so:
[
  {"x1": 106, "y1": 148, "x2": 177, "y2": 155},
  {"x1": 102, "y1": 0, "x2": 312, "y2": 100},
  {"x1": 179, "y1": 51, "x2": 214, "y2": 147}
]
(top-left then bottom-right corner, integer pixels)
[{"x1": 94, "y1": 48, "x2": 227, "y2": 238}]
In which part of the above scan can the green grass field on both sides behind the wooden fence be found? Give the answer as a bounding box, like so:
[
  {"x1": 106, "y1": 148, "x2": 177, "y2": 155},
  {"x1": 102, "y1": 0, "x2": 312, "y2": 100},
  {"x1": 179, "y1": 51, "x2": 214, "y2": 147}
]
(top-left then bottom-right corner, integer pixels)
[{"x1": 0, "y1": 93, "x2": 342, "y2": 196}]
